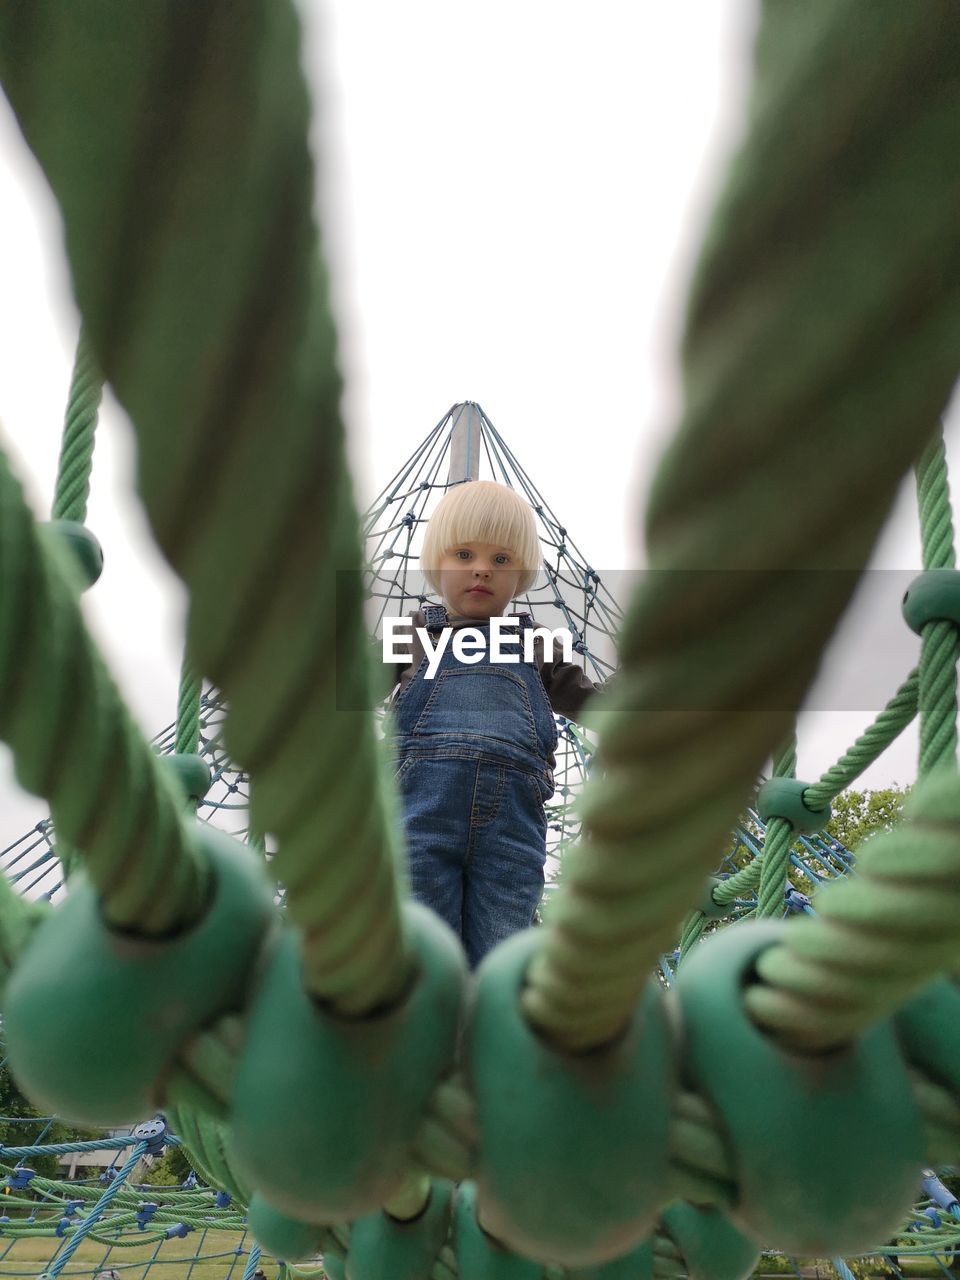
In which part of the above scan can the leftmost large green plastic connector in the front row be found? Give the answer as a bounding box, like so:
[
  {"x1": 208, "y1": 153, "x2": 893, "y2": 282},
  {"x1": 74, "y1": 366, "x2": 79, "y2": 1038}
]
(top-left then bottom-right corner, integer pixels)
[{"x1": 4, "y1": 823, "x2": 275, "y2": 1125}]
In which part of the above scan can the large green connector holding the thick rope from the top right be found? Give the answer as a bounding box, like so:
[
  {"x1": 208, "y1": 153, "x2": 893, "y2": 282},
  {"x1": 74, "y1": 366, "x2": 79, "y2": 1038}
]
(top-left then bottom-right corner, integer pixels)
[{"x1": 466, "y1": 929, "x2": 676, "y2": 1267}]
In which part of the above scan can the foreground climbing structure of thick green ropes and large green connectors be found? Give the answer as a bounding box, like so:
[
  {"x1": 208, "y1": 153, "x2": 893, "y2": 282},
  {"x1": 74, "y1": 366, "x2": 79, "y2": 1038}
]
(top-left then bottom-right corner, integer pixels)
[{"x1": 0, "y1": 0, "x2": 960, "y2": 1280}]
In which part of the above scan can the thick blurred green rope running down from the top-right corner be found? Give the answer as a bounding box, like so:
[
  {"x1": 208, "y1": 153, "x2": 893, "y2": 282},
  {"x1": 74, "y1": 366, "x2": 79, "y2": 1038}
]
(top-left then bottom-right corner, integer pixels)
[{"x1": 524, "y1": 0, "x2": 960, "y2": 1047}]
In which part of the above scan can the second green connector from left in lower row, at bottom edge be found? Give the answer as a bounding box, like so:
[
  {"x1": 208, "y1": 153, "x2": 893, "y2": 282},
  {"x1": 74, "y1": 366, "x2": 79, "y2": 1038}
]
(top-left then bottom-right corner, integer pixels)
[{"x1": 347, "y1": 1181, "x2": 453, "y2": 1280}]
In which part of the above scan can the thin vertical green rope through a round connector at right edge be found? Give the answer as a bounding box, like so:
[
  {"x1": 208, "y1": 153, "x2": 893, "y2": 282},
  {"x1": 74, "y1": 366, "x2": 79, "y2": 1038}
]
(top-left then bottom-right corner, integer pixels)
[{"x1": 916, "y1": 431, "x2": 960, "y2": 777}]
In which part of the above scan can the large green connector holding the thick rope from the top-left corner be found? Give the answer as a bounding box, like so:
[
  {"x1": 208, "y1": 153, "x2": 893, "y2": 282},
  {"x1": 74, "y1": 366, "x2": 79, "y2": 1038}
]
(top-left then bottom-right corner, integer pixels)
[{"x1": 230, "y1": 902, "x2": 466, "y2": 1222}]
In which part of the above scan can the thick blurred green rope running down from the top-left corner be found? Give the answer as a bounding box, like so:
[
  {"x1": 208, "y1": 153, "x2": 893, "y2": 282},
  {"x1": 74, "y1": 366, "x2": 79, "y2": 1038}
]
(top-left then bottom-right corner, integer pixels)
[{"x1": 0, "y1": 0, "x2": 410, "y2": 1015}]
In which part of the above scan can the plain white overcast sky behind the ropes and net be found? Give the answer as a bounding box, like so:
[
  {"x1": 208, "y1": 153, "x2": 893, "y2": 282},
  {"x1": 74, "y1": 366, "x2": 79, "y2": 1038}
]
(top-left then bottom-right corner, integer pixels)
[{"x1": 0, "y1": 0, "x2": 960, "y2": 847}]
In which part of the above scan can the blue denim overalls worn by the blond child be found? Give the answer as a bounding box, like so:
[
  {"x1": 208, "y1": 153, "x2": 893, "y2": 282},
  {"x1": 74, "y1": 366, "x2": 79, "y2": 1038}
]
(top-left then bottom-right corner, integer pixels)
[{"x1": 393, "y1": 605, "x2": 557, "y2": 968}]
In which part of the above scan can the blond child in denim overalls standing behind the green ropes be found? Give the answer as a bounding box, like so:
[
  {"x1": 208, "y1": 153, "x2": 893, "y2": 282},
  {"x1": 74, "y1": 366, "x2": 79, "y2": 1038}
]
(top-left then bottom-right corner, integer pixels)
[{"x1": 392, "y1": 480, "x2": 599, "y2": 968}]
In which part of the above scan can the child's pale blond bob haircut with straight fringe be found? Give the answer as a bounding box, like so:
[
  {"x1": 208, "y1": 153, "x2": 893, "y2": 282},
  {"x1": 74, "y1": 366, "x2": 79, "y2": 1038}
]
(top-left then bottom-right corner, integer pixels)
[{"x1": 420, "y1": 480, "x2": 543, "y2": 595}]
